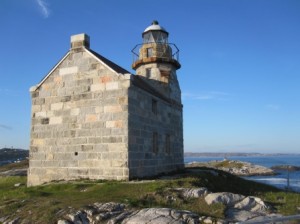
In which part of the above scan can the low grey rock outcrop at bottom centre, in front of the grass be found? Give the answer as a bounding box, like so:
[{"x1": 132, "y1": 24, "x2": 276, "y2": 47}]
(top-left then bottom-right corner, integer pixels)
[{"x1": 57, "y1": 202, "x2": 226, "y2": 224}]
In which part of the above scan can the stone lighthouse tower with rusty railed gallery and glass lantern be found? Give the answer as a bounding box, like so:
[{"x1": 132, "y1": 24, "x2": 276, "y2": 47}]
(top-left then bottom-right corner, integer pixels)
[{"x1": 132, "y1": 21, "x2": 181, "y2": 103}]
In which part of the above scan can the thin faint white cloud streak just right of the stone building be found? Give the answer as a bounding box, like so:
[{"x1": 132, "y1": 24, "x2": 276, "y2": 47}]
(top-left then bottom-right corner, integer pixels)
[{"x1": 182, "y1": 91, "x2": 230, "y2": 100}]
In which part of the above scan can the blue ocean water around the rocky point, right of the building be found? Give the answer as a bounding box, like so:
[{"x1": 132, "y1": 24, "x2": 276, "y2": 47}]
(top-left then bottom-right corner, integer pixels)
[{"x1": 184, "y1": 154, "x2": 300, "y2": 192}]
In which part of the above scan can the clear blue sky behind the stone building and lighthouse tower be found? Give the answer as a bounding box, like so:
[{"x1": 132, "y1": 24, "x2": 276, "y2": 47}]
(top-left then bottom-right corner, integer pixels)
[{"x1": 0, "y1": 0, "x2": 300, "y2": 153}]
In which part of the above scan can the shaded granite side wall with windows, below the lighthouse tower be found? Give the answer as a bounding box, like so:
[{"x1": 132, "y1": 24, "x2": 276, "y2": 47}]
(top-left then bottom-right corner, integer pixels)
[{"x1": 128, "y1": 81, "x2": 184, "y2": 178}]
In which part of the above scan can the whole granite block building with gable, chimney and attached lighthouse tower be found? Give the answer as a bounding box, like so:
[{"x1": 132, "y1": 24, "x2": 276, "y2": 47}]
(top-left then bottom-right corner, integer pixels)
[{"x1": 28, "y1": 21, "x2": 183, "y2": 186}]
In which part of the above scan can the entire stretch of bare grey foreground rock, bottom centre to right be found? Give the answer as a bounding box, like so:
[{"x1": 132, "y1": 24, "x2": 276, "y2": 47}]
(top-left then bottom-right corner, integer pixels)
[{"x1": 57, "y1": 188, "x2": 279, "y2": 224}]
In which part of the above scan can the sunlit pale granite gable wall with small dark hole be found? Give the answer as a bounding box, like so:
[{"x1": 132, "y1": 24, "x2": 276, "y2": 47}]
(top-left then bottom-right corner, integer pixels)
[{"x1": 28, "y1": 49, "x2": 130, "y2": 186}]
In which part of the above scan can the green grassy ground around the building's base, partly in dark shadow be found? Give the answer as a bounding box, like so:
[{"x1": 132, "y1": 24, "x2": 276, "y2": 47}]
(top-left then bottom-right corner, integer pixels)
[{"x1": 0, "y1": 164, "x2": 300, "y2": 223}]
